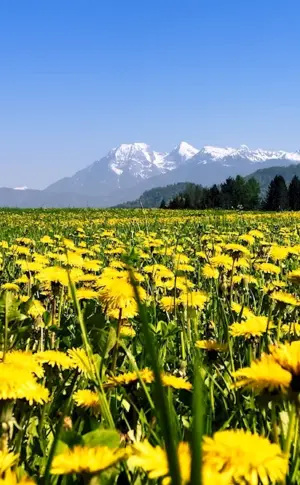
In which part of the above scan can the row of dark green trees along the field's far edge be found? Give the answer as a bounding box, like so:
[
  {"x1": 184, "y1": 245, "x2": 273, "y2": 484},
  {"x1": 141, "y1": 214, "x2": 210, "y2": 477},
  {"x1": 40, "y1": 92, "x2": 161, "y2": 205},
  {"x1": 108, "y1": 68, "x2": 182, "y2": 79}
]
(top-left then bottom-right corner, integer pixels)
[{"x1": 160, "y1": 175, "x2": 300, "y2": 211}]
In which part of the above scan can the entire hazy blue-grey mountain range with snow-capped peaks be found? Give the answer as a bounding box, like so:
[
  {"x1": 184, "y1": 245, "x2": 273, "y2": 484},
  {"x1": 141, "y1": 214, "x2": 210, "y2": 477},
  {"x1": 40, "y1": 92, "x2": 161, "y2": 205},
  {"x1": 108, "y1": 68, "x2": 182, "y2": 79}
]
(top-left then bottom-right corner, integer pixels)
[{"x1": 0, "y1": 142, "x2": 300, "y2": 207}]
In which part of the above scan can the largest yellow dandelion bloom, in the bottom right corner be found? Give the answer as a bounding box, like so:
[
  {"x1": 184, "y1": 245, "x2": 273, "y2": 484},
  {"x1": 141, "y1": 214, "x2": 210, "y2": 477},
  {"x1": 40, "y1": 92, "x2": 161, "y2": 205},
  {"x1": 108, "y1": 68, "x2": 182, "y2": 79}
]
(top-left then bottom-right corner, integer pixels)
[{"x1": 203, "y1": 429, "x2": 288, "y2": 485}]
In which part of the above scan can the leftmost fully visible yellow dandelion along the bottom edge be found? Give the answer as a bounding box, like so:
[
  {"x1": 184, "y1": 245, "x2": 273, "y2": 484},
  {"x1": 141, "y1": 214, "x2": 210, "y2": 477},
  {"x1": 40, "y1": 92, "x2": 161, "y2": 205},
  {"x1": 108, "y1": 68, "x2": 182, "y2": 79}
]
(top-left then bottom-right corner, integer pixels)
[{"x1": 51, "y1": 446, "x2": 126, "y2": 475}]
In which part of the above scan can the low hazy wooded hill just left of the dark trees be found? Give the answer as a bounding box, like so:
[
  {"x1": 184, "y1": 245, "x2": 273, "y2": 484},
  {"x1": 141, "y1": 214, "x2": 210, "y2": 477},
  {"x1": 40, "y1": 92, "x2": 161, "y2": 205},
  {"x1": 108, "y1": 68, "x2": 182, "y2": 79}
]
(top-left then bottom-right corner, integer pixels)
[{"x1": 117, "y1": 182, "x2": 194, "y2": 208}]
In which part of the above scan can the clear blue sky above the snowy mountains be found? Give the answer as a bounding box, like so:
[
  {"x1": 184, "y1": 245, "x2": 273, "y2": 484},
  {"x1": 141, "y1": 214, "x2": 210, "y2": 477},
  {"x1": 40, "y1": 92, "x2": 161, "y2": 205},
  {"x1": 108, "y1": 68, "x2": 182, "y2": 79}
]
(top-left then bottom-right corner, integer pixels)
[{"x1": 0, "y1": 0, "x2": 300, "y2": 188}]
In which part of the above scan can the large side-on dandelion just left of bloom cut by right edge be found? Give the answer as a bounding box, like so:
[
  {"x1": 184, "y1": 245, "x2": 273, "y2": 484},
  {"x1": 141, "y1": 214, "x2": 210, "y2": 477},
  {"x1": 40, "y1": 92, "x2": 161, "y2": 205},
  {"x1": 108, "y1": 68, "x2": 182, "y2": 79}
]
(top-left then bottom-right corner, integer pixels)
[{"x1": 232, "y1": 354, "x2": 292, "y2": 392}]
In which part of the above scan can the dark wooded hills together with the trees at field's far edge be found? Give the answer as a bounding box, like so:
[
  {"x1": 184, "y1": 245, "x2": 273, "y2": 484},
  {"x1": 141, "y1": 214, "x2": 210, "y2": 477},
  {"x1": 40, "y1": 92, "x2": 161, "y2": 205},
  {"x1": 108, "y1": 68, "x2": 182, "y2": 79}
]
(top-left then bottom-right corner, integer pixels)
[{"x1": 117, "y1": 164, "x2": 300, "y2": 210}]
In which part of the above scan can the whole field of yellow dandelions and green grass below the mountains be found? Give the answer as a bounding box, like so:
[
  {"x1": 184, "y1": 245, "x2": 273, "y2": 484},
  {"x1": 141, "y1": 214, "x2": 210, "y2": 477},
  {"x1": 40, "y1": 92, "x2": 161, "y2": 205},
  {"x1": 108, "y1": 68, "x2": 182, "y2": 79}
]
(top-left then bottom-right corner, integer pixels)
[{"x1": 0, "y1": 210, "x2": 300, "y2": 485}]
